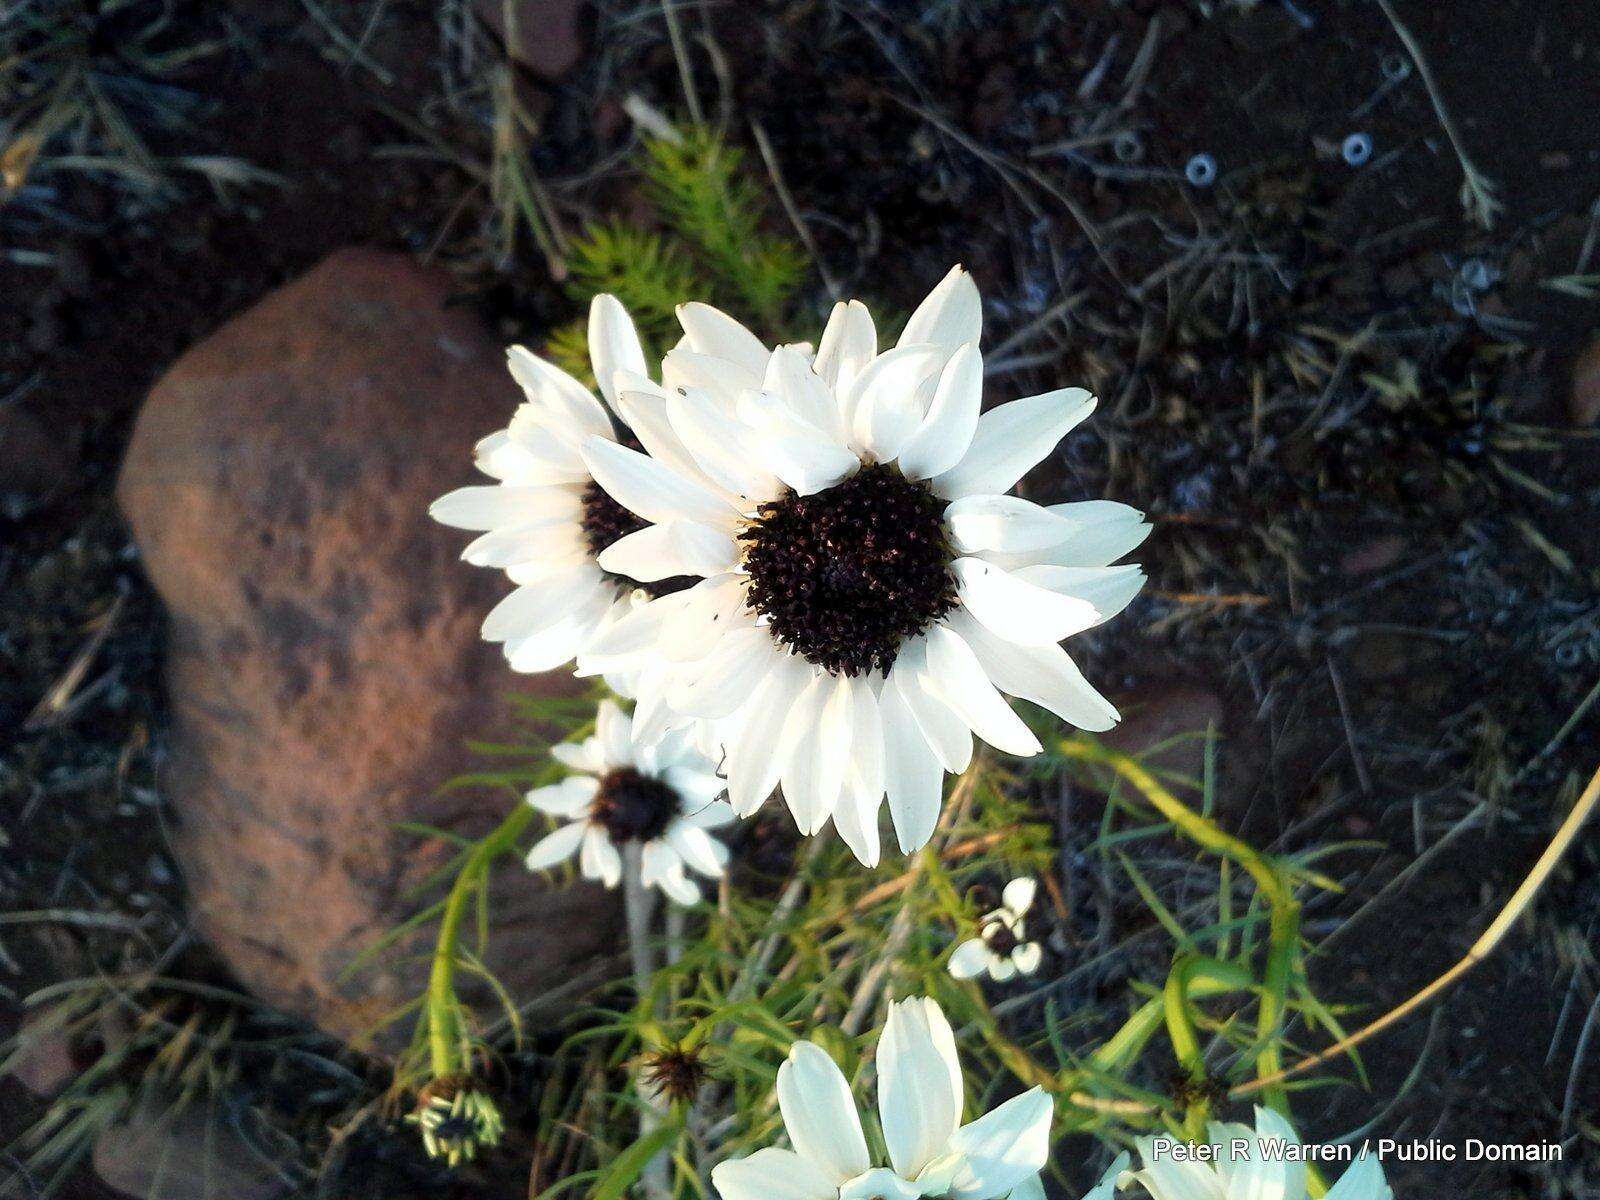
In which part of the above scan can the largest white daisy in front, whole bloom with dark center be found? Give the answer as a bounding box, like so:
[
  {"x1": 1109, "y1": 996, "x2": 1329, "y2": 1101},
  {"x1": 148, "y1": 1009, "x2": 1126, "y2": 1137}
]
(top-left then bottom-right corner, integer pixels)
[{"x1": 582, "y1": 267, "x2": 1149, "y2": 866}]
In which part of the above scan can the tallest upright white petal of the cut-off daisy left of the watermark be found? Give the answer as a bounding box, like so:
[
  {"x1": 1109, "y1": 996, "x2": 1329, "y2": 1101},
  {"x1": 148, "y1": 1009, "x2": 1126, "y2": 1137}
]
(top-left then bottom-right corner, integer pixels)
[{"x1": 877, "y1": 1000, "x2": 962, "y2": 1179}]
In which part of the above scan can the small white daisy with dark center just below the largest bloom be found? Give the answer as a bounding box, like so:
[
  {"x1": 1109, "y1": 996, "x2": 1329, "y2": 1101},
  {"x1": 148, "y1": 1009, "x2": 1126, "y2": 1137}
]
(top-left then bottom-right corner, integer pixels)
[{"x1": 528, "y1": 701, "x2": 733, "y2": 904}]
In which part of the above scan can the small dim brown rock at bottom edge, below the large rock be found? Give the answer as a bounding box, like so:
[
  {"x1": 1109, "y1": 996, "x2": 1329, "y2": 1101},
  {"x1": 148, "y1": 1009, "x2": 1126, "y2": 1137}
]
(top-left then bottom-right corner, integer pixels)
[{"x1": 93, "y1": 1101, "x2": 291, "y2": 1200}]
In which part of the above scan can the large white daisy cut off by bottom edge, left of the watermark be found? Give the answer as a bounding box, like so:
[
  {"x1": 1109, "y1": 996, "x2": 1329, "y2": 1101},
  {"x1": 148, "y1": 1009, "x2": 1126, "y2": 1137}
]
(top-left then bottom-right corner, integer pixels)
[{"x1": 710, "y1": 998, "x2": 1051, "y2": 1200}]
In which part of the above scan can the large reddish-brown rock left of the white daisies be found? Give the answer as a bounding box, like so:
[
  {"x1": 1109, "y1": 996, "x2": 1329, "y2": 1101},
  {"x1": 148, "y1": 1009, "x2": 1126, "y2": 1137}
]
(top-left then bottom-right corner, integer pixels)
[{"x1": 118, "y1": 250, "x2": 619, "y2": 1043}]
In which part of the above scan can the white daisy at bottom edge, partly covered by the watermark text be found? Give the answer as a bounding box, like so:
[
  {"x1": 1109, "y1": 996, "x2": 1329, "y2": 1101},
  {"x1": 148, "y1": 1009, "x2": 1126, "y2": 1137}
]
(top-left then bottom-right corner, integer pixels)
[{"x1": 1122, "y1": 1107, "x2": 1394, "y2": 1200}]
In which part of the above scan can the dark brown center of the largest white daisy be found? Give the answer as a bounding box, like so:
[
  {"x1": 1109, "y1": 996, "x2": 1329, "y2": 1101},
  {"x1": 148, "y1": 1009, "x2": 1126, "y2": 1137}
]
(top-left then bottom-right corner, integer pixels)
[{"x1": 741, "y1": 464, "x2": 955, "y2": 675}]
